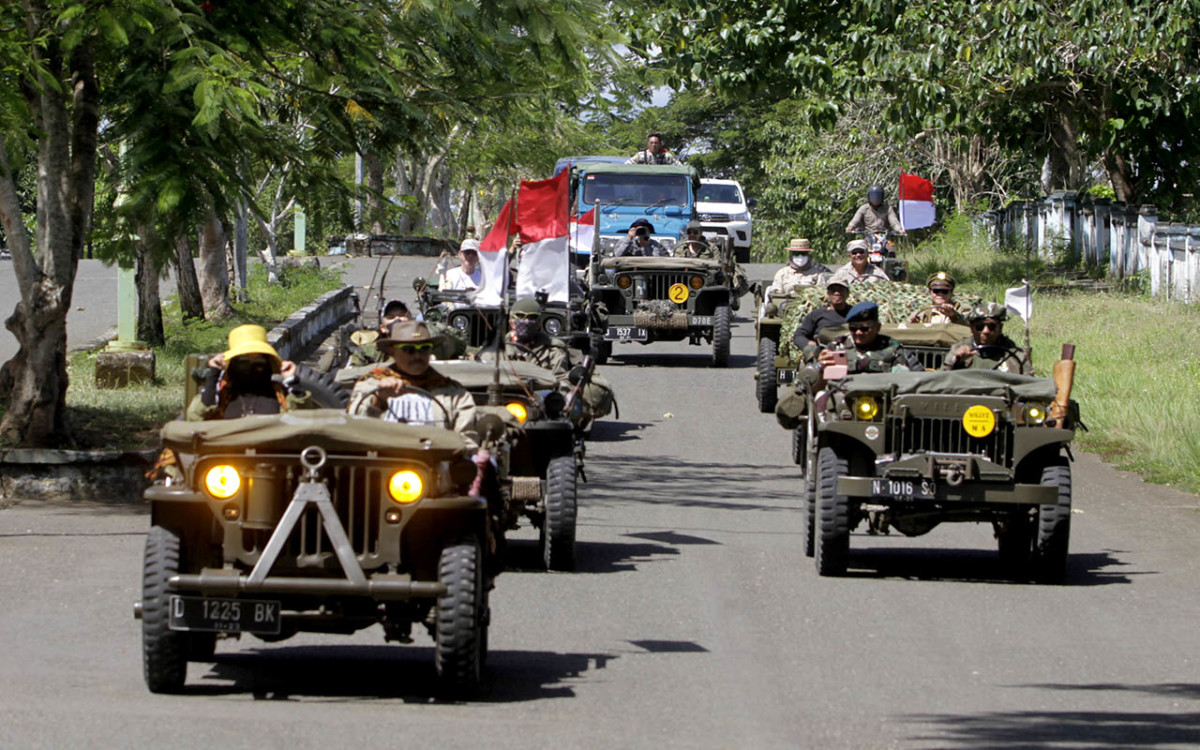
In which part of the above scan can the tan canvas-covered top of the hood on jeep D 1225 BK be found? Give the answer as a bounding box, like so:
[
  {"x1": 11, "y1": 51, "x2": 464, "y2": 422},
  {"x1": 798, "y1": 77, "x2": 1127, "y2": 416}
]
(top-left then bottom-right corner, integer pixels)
[{"x1": 162, "y1": 409, "x2": 467, "y2": 461}]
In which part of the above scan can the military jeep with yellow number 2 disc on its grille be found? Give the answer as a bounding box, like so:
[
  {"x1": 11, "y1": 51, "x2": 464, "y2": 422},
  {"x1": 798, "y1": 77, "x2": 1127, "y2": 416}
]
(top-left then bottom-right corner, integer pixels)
[{"x1": 588, "y1": 254, "x2": 733, "y2": 367}]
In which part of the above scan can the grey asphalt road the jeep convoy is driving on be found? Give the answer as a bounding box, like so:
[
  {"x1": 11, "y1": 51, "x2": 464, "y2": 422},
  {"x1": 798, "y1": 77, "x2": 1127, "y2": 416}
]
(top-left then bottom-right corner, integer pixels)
[{"x1": 0, "y1": 260, "x2": 1200, "y2": 749}]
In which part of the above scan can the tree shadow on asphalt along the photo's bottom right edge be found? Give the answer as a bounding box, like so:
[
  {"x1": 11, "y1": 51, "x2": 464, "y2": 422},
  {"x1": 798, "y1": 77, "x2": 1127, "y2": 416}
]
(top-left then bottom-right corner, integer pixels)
[{"x1": 905, "y1": 710, "x2": 1200, "y2": 750}]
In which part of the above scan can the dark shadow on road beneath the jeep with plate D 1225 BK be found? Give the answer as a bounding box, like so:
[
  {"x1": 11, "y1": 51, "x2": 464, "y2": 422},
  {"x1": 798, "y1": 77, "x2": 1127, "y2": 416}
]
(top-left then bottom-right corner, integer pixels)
[{"x1": 196, "y1": 634, "x2": 618, "y2": 703}]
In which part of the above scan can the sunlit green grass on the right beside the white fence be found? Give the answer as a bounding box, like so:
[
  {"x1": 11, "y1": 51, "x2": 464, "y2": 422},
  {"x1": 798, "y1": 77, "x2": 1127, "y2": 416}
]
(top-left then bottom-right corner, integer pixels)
[{"x1": 906, "y1": 213, "x2": 1200, "y2": 492}]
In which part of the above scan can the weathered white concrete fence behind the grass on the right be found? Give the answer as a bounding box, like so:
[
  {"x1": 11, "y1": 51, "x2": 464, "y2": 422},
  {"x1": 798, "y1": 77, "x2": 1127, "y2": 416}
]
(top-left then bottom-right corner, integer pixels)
[{"x1": 979, "y1": 192, "x2": 1200, "y2": 302}]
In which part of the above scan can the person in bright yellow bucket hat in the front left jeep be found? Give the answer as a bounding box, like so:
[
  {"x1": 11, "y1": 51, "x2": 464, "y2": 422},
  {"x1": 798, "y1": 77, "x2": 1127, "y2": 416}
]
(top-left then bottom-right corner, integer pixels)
[{"x1": 187, "y1": 325, "x2": 310, "y2": 421}]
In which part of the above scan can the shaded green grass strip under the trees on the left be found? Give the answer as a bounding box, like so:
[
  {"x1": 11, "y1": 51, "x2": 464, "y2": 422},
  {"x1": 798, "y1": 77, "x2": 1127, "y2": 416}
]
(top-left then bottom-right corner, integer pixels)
[{"x1": 57, "y1": 266, "x2": 342, "y2": 450}]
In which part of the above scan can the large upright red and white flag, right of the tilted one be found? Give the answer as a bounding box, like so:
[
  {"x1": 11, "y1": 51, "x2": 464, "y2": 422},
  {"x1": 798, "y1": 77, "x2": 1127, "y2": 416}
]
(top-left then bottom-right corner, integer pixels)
[{"x1": 517, "y1": 169, "x2": 571, "y2": 302}]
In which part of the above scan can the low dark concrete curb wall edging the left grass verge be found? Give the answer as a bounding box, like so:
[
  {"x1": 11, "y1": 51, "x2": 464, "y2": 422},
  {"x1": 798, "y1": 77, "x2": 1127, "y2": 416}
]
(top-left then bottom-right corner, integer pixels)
[{"x1": 0, "y1": 287, "x2": 359, "y2": 503}]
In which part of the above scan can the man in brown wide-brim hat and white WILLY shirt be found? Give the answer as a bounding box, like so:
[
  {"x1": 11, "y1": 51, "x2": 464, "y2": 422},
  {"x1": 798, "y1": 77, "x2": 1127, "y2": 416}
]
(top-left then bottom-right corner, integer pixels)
[{"x1": 347, "y1": 320, "x2": 476, "y2": 448}]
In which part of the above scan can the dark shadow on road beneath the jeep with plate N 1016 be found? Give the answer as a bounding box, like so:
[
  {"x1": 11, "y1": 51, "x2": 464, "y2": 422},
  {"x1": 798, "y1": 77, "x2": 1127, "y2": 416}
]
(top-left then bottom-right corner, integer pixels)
[{"x1": 848, "y1": 544, "x2": 1128, "y2": 586}]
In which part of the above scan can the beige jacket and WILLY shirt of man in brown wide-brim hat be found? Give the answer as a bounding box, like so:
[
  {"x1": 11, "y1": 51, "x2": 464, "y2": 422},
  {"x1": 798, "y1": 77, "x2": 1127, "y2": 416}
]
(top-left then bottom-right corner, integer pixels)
[{"x1": 346, "y1": 366, "x2": 479, "y2": 450}]
